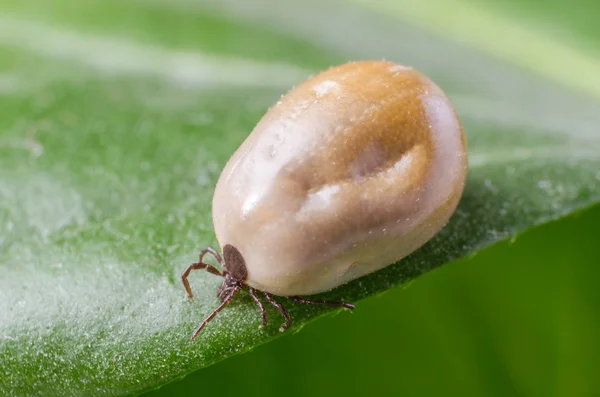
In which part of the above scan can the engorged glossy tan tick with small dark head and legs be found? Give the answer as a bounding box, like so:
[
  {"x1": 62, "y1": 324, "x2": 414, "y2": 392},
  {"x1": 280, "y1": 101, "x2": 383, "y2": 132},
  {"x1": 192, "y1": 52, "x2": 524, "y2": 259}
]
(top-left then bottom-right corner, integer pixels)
[{"x1": 183, "y1": 61, "x2": 467, "y2": 339}]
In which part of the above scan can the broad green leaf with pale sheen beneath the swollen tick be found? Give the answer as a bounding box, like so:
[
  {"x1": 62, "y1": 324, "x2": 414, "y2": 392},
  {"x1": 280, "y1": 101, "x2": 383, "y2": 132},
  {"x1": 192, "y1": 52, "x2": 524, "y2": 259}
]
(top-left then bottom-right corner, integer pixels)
[{"x1": 0, "y1": 0, "x2": 600, "y2": 396}]
